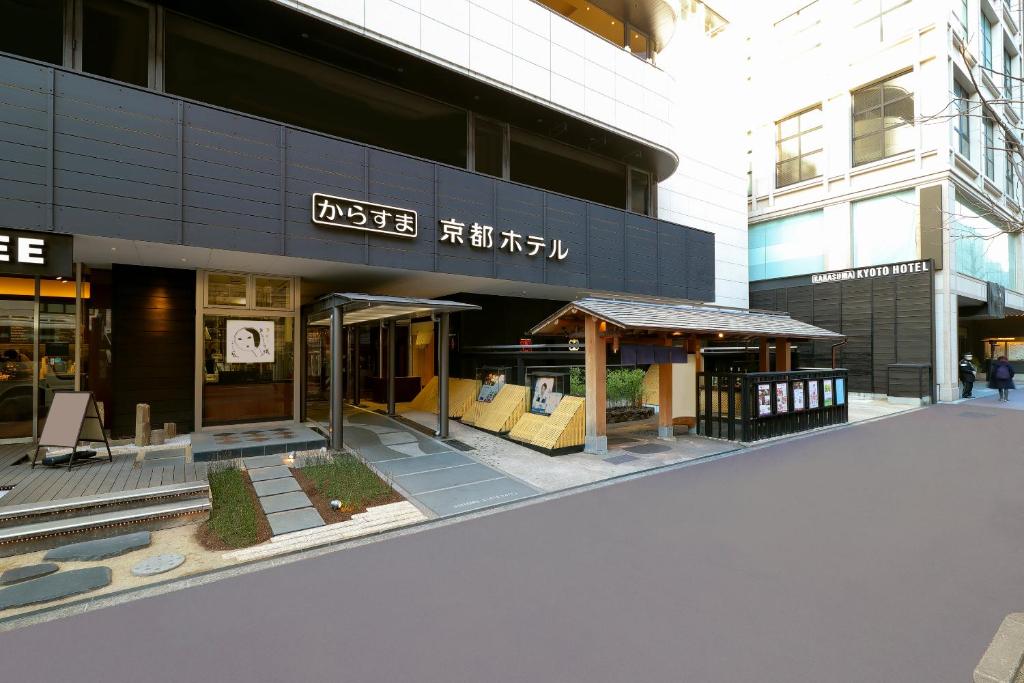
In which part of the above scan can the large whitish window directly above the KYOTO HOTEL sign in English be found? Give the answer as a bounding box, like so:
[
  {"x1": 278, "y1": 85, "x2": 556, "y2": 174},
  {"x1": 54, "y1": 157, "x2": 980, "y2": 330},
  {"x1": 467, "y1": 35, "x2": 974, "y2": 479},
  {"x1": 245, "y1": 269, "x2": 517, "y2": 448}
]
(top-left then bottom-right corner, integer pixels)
[{"x1": 850, "y1": 189, "x2": 919, "y2": 267}]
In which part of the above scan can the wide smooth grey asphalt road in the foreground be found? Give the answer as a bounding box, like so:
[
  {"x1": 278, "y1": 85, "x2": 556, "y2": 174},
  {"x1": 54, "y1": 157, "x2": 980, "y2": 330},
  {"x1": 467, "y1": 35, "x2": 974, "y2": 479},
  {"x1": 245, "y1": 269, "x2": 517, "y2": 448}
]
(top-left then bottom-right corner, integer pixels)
[{"x1": 0, "y1": 392, "x2": 1024, "y2": 683}]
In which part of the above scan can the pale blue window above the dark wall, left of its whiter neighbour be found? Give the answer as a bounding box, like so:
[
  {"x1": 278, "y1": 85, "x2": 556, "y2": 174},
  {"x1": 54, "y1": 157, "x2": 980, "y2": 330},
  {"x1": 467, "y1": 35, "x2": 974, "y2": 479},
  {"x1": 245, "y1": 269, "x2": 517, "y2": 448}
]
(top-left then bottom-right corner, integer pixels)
[{"x1": 748, "y1": 210, "x2": 827, "y2": 281}]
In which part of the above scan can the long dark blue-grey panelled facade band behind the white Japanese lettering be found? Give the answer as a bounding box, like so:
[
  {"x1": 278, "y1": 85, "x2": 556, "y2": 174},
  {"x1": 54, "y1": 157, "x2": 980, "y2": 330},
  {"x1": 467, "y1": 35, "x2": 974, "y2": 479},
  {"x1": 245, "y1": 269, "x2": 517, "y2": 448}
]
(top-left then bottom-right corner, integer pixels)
[{"x1": 0, "y1": 57, "x2": 715, "y2": 301}]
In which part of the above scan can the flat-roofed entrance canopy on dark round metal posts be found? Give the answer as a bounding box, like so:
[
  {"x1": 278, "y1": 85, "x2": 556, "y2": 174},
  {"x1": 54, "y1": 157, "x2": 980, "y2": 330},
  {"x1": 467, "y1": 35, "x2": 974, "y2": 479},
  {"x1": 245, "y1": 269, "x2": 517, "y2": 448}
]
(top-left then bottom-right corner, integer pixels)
[{"x1": 302, "y1": 292, "x2": 480, "y2": 450}]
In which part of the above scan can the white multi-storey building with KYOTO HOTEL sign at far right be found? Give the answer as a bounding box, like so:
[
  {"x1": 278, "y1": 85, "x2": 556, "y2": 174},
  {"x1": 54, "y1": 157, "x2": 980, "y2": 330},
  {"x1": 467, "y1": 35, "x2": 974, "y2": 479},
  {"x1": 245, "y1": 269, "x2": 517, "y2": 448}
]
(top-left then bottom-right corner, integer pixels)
[{"x1": 744, "y1": 0, "x2": 1024, "y2": 400}]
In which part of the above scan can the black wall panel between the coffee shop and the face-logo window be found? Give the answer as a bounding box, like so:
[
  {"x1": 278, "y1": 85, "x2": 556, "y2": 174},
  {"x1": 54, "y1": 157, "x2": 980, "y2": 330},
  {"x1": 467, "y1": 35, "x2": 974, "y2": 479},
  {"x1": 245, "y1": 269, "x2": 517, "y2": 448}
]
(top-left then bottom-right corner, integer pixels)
[{"x1": 112, "y1": 265, "x2": 196, "y2": 435}]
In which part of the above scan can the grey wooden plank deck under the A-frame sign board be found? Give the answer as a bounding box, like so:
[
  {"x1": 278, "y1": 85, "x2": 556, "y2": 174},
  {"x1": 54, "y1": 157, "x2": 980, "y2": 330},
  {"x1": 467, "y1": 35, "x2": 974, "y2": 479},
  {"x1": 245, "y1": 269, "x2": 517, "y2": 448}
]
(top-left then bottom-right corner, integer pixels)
[{"x1": 0, "y1": 443, "x2": 208, "y2": 507}]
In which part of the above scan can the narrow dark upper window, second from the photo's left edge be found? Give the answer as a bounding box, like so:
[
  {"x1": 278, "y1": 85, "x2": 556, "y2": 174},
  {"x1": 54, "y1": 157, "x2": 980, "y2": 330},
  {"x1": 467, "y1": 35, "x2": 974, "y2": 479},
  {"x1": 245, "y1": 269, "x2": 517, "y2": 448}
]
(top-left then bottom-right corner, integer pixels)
[{"x1": 82, "y1": 0, "x2": 151, "y2": 86}]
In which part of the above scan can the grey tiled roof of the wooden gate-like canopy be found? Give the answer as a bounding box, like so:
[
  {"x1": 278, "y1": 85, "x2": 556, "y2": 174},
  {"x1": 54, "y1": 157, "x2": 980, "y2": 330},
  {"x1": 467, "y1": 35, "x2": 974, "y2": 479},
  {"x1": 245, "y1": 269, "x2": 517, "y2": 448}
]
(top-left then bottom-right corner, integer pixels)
[{"x1": 529, "y1": 298, "x2": 845, "y2": 339}]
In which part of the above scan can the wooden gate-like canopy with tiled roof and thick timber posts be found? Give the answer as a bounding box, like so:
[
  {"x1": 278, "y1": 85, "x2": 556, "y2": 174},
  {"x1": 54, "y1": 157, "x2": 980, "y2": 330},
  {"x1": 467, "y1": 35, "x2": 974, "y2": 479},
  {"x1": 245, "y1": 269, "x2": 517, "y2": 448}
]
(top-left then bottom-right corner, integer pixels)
[{"x1": 529, "y1": 298, "x2": 846, "y2": 454}]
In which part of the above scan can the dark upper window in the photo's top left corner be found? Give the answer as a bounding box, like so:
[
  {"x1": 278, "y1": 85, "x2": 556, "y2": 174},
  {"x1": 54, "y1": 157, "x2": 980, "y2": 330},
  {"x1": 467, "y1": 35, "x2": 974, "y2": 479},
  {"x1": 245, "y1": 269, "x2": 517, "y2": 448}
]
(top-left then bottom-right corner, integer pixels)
[{"x1": 0, "y1": 0, "x2": 65, "y2": 65}]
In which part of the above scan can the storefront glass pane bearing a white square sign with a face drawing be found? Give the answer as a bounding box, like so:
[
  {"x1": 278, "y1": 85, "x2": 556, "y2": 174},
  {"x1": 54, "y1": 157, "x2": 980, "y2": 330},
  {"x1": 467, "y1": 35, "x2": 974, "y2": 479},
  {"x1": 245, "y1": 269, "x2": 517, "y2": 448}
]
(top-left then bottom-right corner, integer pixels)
[{"x1": 201, "y1": 314, "x2": 295, "y2": 426}]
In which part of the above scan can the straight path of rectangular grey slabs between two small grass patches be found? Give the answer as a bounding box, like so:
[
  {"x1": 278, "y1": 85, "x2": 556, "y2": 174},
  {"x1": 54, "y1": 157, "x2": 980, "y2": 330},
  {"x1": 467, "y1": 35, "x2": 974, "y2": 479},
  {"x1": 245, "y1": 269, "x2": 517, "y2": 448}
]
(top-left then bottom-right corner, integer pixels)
[{"x1": 242, "y1": 455, "x2": 324, "y2": 536}]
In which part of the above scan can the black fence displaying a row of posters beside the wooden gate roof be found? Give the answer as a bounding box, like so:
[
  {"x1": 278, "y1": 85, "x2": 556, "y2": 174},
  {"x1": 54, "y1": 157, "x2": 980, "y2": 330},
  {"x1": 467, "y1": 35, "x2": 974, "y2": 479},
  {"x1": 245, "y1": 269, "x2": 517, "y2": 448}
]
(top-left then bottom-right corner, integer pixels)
[{"x1": 696, "y1": 369, "x2": 849, "y2": 442}]
